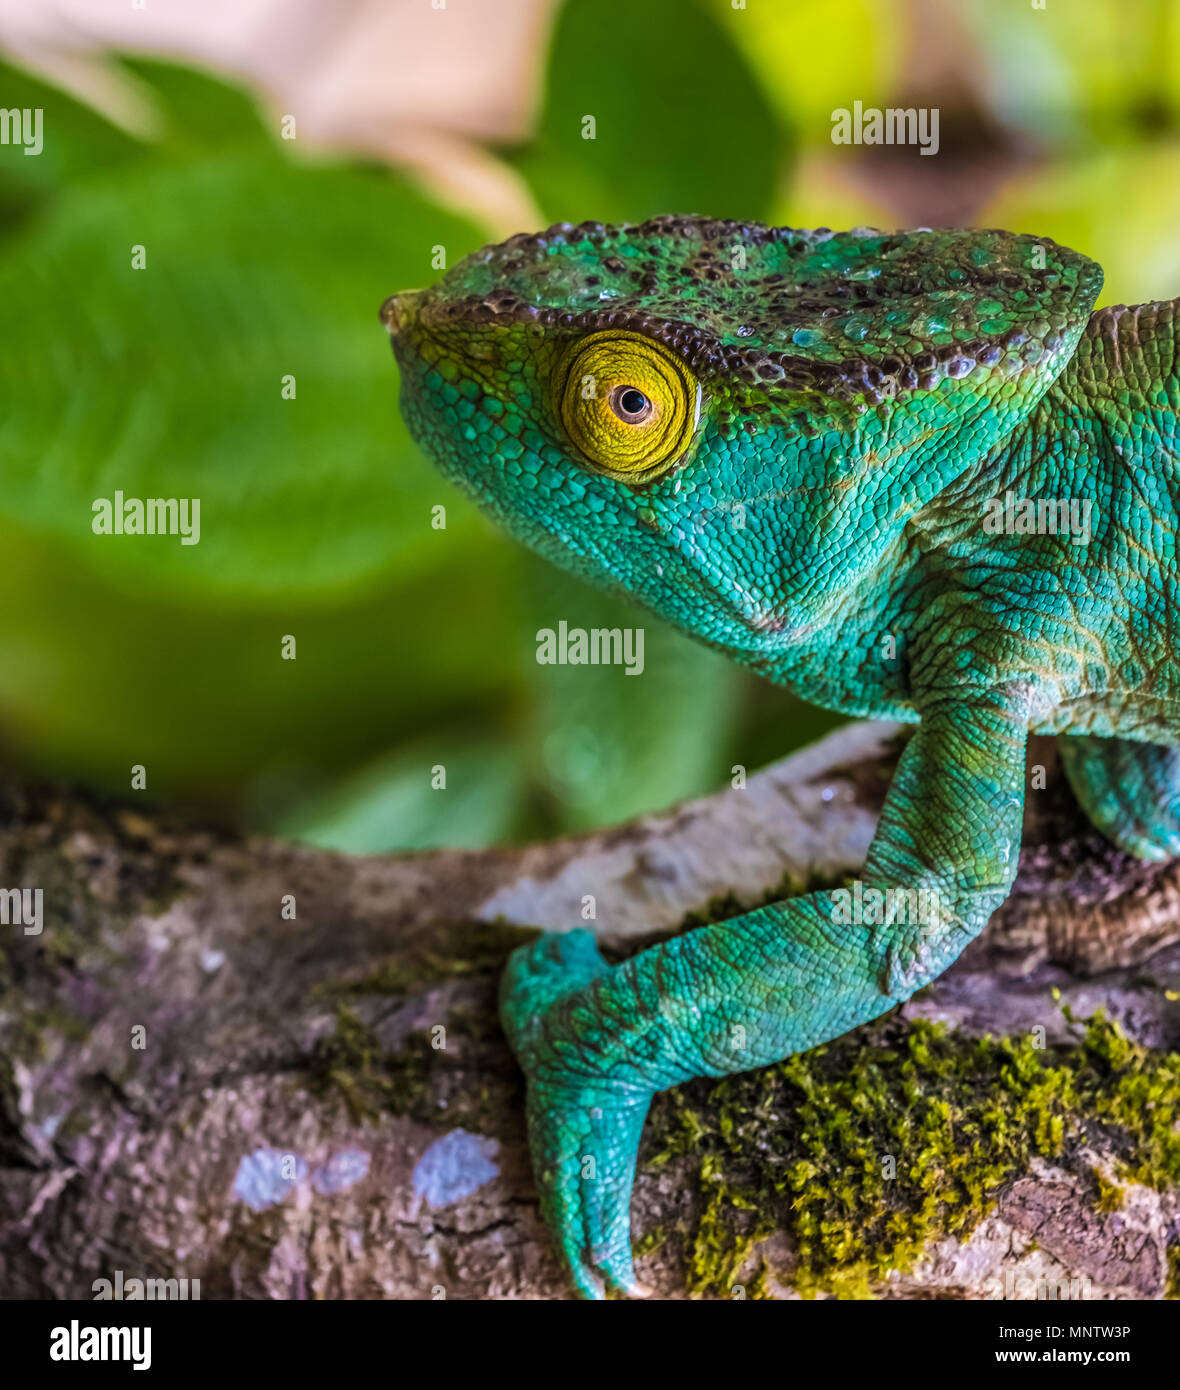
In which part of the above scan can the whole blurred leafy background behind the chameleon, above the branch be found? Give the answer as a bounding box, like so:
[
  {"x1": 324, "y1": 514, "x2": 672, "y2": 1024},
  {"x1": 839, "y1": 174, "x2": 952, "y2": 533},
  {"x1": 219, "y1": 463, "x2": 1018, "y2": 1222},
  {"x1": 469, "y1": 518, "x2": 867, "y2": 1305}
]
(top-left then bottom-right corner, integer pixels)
[{"x1": 0, "y1": 0, "x2": 1180, "y2": 851}]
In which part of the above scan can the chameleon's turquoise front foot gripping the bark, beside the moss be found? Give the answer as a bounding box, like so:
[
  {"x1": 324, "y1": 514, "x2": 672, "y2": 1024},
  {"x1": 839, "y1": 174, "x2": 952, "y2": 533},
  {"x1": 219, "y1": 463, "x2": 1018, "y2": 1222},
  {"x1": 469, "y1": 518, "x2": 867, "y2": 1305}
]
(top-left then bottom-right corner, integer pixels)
[{"x1": 500, "y1": 931, "x2": 652, "y2": 1298}]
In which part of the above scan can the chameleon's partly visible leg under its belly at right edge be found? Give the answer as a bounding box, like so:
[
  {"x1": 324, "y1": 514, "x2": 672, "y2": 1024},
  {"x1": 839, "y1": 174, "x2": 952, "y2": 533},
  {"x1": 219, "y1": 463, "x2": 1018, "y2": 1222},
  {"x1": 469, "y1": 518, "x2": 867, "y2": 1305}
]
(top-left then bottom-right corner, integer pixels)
[{"x1": 1058, "y1": 734, "x2": 1180, "y2": 859}]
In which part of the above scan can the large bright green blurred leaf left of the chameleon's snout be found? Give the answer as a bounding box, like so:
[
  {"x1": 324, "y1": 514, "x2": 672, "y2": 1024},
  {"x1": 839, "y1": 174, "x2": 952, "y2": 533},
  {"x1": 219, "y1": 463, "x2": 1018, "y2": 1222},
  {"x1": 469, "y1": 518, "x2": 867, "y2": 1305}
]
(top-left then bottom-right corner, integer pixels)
[{"x1": 0, "y1": 76, "x2": 484, "y2": 603}]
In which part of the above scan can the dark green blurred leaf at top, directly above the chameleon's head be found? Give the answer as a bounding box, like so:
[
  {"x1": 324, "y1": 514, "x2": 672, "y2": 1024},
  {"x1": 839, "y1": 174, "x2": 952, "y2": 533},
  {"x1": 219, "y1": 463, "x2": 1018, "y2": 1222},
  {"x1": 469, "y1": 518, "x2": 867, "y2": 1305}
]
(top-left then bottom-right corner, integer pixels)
[{"x1": 517, "y1": 0, "x2": 785, "y2": 222}]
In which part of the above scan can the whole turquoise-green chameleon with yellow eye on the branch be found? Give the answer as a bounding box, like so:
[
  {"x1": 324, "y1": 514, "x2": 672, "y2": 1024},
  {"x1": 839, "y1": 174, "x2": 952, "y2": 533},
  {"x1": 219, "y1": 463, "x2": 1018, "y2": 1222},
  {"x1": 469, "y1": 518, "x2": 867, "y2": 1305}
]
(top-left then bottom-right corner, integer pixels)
[{"x1": 382, "y1": 217, "x2": 1180, "y2": 1297}]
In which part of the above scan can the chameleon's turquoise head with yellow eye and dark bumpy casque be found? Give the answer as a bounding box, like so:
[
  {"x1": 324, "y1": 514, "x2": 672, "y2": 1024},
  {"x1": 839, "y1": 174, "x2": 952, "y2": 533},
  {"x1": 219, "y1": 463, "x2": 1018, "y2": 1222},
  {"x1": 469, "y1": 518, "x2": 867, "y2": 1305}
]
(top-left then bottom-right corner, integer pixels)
[{"x1": 382, "y1": 217, "x2": 1101, "y2": 657}]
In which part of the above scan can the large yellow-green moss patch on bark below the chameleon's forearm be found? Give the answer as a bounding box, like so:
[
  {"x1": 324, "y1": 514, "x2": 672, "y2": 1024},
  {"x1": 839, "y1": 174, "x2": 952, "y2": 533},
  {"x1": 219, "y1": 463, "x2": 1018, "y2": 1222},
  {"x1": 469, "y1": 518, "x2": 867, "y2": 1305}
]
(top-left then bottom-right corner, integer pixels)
[{"x1": 648, "y1": 1013, "x2": 1180, "y2": 1298}]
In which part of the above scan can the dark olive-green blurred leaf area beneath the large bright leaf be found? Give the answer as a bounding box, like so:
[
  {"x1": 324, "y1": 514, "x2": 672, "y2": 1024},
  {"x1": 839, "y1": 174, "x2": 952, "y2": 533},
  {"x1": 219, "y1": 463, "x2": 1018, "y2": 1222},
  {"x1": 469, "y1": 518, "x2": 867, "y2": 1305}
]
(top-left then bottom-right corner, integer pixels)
[{"x1": 0, "y1": 517, "x2": 520, "y2": 806}]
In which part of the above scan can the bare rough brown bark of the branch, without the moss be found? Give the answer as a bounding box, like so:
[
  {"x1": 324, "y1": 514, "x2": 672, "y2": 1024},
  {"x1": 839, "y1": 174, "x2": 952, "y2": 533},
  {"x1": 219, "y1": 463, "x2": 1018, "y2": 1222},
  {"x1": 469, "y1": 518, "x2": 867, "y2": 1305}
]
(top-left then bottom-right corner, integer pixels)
[{"x1": 0, "y1": 724, "x2": 1180, "y2": 1298}]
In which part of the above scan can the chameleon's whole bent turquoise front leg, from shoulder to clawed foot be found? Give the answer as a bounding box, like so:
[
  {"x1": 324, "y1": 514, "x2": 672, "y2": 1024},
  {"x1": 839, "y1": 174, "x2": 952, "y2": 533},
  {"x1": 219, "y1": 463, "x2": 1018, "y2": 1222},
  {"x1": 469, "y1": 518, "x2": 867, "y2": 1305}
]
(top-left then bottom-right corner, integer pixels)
[{"x1": 500, "y1": 701, "x2": 1029, "y2": 1298}]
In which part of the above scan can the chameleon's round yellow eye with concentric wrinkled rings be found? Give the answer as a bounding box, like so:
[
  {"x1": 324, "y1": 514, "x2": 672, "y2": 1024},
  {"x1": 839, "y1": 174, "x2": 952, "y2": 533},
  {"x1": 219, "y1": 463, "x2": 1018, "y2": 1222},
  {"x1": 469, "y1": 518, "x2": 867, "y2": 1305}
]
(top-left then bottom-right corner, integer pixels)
[{"x1": 555, "y1": 329, "x2": 700, "y2": 482}]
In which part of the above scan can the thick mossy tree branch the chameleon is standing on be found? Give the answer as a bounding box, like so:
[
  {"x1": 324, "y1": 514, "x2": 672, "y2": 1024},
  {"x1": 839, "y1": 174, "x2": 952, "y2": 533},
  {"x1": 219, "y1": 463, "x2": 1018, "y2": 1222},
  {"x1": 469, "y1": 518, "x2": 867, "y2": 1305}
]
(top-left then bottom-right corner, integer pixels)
[{"x1": 0, "y1": 726, "x2": 1180, "y2": 1298}]
